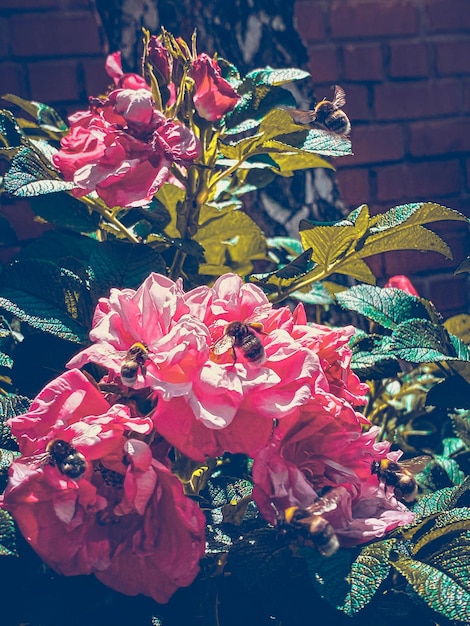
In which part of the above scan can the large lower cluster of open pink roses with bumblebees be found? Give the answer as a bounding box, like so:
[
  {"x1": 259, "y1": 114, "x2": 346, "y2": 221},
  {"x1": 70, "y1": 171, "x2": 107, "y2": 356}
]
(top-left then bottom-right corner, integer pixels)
[{"x1": 3, "y1": 274, "x2": 413, "y2": 602}]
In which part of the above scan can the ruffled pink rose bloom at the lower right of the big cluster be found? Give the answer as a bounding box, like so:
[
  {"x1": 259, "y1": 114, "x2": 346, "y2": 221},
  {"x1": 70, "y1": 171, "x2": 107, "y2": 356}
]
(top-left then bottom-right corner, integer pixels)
[{"x1": 253, "y1": 393, "x2": 414, "y2": 546}]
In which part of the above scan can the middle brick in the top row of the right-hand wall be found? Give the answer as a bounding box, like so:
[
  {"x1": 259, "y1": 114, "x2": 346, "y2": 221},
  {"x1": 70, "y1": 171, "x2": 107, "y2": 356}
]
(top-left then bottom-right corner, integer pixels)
[{"x1": 330, "y1": 0, "x2": 419, "y2": 39}]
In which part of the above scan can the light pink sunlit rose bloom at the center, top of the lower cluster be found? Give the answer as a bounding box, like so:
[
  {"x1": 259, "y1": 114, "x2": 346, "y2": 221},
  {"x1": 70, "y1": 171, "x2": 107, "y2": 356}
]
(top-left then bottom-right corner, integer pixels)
[{"x1": 68, "y1": 274, "x2": 321, "y2": 460}]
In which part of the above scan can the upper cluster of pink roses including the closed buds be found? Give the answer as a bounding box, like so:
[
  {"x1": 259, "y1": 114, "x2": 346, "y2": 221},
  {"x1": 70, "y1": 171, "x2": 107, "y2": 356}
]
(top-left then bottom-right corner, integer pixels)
[{"x1": 53, "y1": 36, "x2": 240, "y2": 207}]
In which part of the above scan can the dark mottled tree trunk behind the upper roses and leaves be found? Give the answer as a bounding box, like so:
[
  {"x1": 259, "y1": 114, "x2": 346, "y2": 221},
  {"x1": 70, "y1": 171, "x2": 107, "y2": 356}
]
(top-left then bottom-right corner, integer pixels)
[{"x1": 94, "y1": 0, "x2": 347, "y2": 237}]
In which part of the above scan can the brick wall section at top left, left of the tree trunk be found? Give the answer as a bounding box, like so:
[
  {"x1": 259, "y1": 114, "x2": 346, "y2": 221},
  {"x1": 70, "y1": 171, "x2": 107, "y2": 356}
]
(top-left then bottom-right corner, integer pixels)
[{"x1": 0, "y1": 0, "x2": 110, "y2": 114}]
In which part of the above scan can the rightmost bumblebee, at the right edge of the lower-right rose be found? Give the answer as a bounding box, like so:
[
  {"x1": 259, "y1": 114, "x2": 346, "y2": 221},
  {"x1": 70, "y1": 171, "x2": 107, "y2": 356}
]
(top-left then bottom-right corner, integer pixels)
[{"x1": 371, "y1": 455, "x2": 430, "y2": 502}]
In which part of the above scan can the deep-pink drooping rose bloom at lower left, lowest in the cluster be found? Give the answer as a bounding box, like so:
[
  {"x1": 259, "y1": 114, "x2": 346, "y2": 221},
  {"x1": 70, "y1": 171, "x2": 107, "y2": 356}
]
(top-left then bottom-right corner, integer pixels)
[{"x1": 1, "y1": 370, "x2": 205, "y2": 602}]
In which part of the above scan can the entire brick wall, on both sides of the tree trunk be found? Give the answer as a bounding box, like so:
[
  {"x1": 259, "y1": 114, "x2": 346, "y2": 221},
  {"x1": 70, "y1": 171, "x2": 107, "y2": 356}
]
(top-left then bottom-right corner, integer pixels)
[{"x1": 0, "y1": 0, "x2": 470, "y2": 315}]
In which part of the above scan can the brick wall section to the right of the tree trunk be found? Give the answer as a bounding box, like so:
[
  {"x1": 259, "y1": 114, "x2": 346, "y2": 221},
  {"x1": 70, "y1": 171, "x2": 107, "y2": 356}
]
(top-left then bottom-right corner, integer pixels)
[{"x1": 296, "y1": 0, "x2": 470, "y2": 316}]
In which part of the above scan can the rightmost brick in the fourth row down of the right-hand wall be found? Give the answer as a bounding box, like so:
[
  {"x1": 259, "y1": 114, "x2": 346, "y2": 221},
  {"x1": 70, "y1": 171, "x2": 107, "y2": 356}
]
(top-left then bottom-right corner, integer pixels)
[{"x1": 410, "y1": 117, "x2": 470, "y2": 156}]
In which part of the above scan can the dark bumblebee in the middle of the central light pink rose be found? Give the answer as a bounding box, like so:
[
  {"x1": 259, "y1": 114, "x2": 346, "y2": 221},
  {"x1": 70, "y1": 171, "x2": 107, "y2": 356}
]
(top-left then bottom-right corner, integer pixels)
[{"x1": 213, "y1": 322, "x2": 266, "y2": 365}]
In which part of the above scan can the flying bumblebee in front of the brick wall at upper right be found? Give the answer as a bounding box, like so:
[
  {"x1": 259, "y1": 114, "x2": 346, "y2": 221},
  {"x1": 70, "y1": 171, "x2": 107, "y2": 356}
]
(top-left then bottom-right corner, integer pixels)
[{"x1": 283, "y1": 85, "x2": 351, "y2": 137}]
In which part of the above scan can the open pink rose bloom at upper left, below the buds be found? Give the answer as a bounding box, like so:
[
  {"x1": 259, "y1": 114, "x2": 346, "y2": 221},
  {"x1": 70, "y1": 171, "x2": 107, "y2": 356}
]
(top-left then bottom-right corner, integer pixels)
[{"x1": 53, "y1": 87, "x2": 201, "y2": 207}]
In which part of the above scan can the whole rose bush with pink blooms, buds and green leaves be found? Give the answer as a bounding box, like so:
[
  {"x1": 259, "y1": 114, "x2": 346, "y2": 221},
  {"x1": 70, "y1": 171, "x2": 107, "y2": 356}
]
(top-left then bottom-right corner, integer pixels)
[{"x1": 0, "y1": 29, "x2": 462, "y2": 624}]
